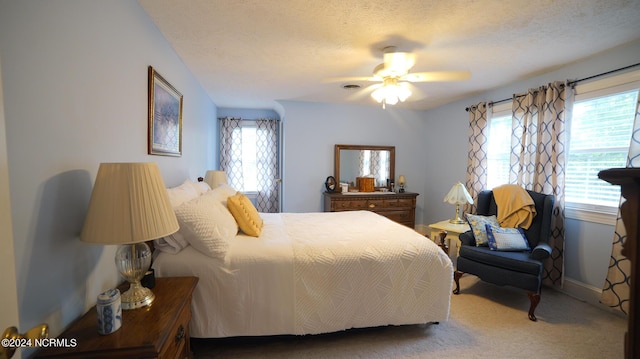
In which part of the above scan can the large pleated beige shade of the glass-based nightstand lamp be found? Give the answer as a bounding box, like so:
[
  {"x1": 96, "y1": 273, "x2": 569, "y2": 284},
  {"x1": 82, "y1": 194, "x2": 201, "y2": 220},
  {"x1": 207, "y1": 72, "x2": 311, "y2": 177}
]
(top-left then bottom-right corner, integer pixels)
[{"x1": 80, "y1": 162, "x2": 179, "y2": 244}]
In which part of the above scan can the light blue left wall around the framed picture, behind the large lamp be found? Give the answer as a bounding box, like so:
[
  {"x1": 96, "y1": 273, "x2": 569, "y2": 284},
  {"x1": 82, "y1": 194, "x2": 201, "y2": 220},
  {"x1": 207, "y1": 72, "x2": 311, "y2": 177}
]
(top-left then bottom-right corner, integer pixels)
[{"x1": 0, "y1": 0, "x2": 217, "y2": 335}]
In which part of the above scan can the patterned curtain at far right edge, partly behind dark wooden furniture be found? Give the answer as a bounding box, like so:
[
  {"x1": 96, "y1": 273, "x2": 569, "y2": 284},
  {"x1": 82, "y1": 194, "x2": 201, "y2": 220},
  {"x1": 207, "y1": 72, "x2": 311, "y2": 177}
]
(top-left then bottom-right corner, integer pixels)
[{"x1": 600, "y1": 100, "x2": 640, "y2": 314}]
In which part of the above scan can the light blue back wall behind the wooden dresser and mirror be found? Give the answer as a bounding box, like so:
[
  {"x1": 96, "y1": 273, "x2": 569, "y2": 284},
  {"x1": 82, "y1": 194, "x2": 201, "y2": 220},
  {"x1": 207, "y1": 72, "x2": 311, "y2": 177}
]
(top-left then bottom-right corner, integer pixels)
[{"x1": 281, "y1": 101, "x2": 429, "y2": 219}]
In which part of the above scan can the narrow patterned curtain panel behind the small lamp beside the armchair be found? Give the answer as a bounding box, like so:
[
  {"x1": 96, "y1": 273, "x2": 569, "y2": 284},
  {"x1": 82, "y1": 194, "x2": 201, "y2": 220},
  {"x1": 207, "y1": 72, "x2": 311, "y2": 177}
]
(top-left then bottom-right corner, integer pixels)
[{"x1": 464, "y1": 102, "x2": 489, "y2": 214}]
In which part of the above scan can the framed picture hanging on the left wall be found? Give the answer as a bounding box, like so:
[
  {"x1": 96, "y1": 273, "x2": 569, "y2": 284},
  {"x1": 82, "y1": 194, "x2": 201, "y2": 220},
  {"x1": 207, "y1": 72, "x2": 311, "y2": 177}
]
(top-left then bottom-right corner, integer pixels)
[{"x1": 148, "y1": 66, "x2": 182, "y2": 156}]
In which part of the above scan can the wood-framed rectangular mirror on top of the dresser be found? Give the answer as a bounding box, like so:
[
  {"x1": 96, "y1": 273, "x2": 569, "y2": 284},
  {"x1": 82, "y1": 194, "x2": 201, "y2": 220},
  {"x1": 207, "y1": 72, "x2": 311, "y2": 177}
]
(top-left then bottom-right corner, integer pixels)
[{"x1": 334, "y1": 145, "x2": 396, "y2": 190}]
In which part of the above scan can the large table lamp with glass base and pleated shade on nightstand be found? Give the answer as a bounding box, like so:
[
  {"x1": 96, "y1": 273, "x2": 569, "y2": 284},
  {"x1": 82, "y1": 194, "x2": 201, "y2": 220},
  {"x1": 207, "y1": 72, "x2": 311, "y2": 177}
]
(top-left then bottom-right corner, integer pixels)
[{"x1": 80, "y1": 163, "x2": 179, "y2": 309}]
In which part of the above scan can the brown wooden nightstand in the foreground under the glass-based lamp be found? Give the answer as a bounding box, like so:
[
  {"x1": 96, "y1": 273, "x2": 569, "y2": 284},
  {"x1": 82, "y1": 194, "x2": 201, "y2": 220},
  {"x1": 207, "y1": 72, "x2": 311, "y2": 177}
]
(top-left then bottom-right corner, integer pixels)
[{"x1": 37, "y1": 277, "x2": 198, "y2": 358}]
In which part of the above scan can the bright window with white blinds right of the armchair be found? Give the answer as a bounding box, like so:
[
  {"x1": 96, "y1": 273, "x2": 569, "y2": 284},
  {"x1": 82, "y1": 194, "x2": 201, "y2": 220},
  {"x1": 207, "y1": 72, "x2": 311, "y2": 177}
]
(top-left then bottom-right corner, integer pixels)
[{"x1": 565, "y1": 89, "x2": 638, "y2": 212}]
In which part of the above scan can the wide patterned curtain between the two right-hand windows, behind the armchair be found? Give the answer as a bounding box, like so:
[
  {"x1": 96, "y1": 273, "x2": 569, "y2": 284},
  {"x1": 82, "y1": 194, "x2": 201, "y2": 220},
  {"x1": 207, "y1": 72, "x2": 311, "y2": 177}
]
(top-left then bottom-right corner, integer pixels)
[{"x1": 509, "y1": 82, "x2": 573, "y2": 285}]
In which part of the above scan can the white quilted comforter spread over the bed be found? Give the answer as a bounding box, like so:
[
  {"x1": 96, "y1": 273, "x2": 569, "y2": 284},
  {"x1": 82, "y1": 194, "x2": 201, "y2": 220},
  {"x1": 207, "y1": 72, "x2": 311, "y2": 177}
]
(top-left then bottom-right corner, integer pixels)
[{"x1": 154, "y1": 211, "x2": 453, "y2": 338}]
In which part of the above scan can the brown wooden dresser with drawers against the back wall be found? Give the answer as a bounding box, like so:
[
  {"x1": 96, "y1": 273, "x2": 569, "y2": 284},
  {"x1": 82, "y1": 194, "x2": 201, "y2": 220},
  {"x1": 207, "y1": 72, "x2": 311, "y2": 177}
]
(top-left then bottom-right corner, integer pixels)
[{"x1": 324, "y1": 192, "x2": 418, "y2": 228}]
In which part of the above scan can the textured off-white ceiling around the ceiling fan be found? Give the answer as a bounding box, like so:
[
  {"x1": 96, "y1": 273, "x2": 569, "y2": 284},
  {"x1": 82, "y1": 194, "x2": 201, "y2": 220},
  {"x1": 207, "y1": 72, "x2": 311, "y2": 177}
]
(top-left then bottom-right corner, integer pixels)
[{"x1": 138, "y1": 0, "x2": 640, "y2": 109}]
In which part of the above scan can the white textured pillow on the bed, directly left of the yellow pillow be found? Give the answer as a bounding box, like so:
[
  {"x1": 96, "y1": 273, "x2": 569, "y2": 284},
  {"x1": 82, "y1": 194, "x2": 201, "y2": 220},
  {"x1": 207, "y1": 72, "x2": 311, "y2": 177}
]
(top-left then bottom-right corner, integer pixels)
[{"x1": 174, "y1": 191, "x2": 238, "y2": 258}]
